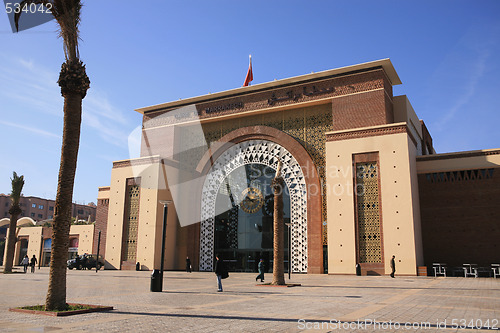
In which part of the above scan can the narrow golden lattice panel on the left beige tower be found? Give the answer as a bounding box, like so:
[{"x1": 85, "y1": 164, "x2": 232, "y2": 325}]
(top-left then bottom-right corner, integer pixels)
[{"x1": 122, "y1": 185, "x2": 140, "y2": 262}]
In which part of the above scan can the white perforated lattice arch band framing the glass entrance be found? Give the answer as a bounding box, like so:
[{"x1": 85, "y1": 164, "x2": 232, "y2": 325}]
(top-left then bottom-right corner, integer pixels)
[{"x1": 199, "y1": 140, "x2": 307, "y2": 272}]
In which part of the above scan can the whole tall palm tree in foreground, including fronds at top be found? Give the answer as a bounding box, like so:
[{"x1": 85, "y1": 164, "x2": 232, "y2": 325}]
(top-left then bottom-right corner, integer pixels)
[{"x1": 15, "y1": 0, "x2": 90, "y2": 310}]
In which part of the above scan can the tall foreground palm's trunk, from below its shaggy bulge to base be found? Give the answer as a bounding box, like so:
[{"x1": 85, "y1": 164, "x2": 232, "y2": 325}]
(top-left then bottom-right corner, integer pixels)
[{"x1": 45, "y1": 87, "x2": 83, "y2": 310}]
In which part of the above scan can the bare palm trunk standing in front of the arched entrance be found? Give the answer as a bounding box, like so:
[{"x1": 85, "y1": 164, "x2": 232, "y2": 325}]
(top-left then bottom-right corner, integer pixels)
[{"x1": 271, "y1": 177, "x2": 285, "y2": 285}]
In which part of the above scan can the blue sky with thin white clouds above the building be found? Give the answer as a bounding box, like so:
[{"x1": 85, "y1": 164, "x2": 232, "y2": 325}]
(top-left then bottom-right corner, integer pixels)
[{"x1": 0, "y1": 0, "x2": 500, "y2": 203}]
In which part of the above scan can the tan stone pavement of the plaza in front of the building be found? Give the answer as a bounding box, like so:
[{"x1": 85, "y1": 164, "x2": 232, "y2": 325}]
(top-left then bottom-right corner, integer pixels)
[{"x1": 0, "y1": 268, "x2": 500, "y2": 332}]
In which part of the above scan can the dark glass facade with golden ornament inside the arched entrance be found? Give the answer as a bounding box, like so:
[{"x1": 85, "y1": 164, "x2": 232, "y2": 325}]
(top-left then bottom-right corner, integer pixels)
[{"x1": 214, "y1": 164, "x2": 290, "y2": 272}]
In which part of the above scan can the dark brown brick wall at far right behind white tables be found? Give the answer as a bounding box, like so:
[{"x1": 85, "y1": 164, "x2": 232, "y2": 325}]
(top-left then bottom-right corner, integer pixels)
[{"x1": 418, "y1": 168, "x2": 500, "y2": 272}]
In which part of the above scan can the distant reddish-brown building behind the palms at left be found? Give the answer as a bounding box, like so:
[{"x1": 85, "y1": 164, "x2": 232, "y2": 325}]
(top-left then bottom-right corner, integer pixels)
[{"x1": 0, "y1": 193, "x2": 97, "y2": 222}]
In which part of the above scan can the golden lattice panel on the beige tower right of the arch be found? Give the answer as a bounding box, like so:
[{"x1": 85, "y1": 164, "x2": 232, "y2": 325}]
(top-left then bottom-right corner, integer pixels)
[{"x1": 356, "y1": 162, "x2": 382, "y2": 263}]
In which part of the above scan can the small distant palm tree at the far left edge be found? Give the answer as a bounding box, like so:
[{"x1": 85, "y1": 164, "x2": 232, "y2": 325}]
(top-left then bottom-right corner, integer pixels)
[{"x1": 3, "y1": 171, "x2": 24, "y2": 273}]
